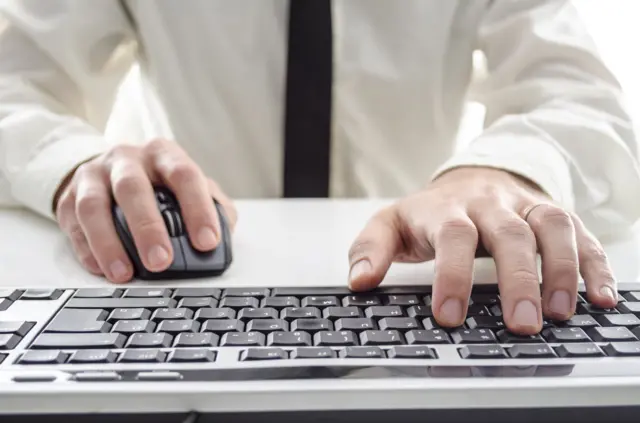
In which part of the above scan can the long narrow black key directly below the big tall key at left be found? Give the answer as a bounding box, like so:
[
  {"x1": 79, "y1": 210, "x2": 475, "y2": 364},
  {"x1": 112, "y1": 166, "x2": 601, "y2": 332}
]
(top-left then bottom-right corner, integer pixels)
[{"x1": 31, "y1": 333, "x2": 127, "y2": 350}]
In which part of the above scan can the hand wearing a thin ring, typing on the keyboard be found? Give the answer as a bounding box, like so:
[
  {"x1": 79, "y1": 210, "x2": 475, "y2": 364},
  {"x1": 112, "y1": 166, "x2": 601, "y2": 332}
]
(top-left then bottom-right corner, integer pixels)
[{"x1": 349, "y1": 168, "x2": 617, "y2": 334}]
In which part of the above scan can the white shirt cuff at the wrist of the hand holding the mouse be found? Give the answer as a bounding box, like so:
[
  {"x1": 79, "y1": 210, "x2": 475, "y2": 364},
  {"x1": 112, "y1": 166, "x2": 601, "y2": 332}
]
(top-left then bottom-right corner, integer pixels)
[{"x1": 12, "y1": 135, "x2": 108, "y2": 219}]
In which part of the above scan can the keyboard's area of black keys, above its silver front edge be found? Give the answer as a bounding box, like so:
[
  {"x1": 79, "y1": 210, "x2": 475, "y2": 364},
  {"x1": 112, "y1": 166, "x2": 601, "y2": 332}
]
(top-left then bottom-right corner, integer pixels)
[{"x1": 0, "y1": 286, "x2": 640, "y2": 378}]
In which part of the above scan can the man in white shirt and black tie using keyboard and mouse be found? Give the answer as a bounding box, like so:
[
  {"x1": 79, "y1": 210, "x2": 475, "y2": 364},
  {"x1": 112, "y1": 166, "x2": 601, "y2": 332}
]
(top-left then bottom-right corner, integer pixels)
[{"x1": 0, "y1": 0, "x2": 640, "y2": 334}]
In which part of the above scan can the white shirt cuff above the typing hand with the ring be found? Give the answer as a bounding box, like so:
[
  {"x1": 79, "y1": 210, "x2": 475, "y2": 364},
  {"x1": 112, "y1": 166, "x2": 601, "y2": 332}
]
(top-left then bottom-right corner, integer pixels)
[{"x1": 432, "y1": 134, "x2": 574, "y2": 210}]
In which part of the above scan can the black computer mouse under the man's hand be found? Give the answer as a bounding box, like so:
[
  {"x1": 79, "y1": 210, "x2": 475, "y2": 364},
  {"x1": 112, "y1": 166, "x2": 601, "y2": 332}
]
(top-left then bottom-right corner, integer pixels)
[{"x1": 112, "y1": 187, "x2": 232, "y2": 280}]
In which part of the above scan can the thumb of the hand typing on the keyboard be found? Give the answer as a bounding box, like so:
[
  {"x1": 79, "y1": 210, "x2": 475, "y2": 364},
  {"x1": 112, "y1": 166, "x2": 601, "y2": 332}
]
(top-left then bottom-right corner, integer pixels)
[{"x1": 349, "y1": 209, "x2": 402, "y2": 291}]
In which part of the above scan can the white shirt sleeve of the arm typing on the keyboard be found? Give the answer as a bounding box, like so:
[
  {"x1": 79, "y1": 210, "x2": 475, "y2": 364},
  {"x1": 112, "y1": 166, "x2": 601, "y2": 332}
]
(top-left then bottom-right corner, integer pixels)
[{"x1": 434, "y1": 0, "x2": 640, "y2": 238}]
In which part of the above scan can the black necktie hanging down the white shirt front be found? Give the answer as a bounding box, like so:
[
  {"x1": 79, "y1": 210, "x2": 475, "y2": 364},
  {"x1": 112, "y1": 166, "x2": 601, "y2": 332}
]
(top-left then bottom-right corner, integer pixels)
[{"x1": 284, "y1": 0, "x2": 333, "y2": 197}]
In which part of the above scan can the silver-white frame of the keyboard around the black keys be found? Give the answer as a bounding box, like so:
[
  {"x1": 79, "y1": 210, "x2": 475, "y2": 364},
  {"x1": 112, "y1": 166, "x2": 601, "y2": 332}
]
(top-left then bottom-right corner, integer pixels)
[{"x1": 0, "y1": 283, "x2": 640, "y2": 421}]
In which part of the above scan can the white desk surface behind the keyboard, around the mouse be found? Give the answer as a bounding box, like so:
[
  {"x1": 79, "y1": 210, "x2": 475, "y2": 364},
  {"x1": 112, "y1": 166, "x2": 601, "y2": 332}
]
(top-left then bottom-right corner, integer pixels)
[{"x1": 0, "y1": 200, "x2": 640, "y2": 287}]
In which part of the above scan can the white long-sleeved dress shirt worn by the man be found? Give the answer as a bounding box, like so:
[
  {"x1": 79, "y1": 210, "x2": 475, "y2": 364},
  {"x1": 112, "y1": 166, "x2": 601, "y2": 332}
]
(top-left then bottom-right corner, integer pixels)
[{"x1": 0, "y1": 0, "x2": 640, "y2": 238}]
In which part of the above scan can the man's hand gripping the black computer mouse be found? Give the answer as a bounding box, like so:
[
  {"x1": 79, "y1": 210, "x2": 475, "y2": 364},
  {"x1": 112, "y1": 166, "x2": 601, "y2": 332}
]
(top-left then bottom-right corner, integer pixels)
[{"x1": 54, "y1": 140, "x2": 237, "y2": 283}]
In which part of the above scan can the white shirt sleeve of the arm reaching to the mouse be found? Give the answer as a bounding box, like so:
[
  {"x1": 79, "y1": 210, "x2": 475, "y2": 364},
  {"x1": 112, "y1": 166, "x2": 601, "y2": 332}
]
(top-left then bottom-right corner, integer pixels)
[{"x1": 0, "y1": 0, "x2": 134, "y2": 222}]
